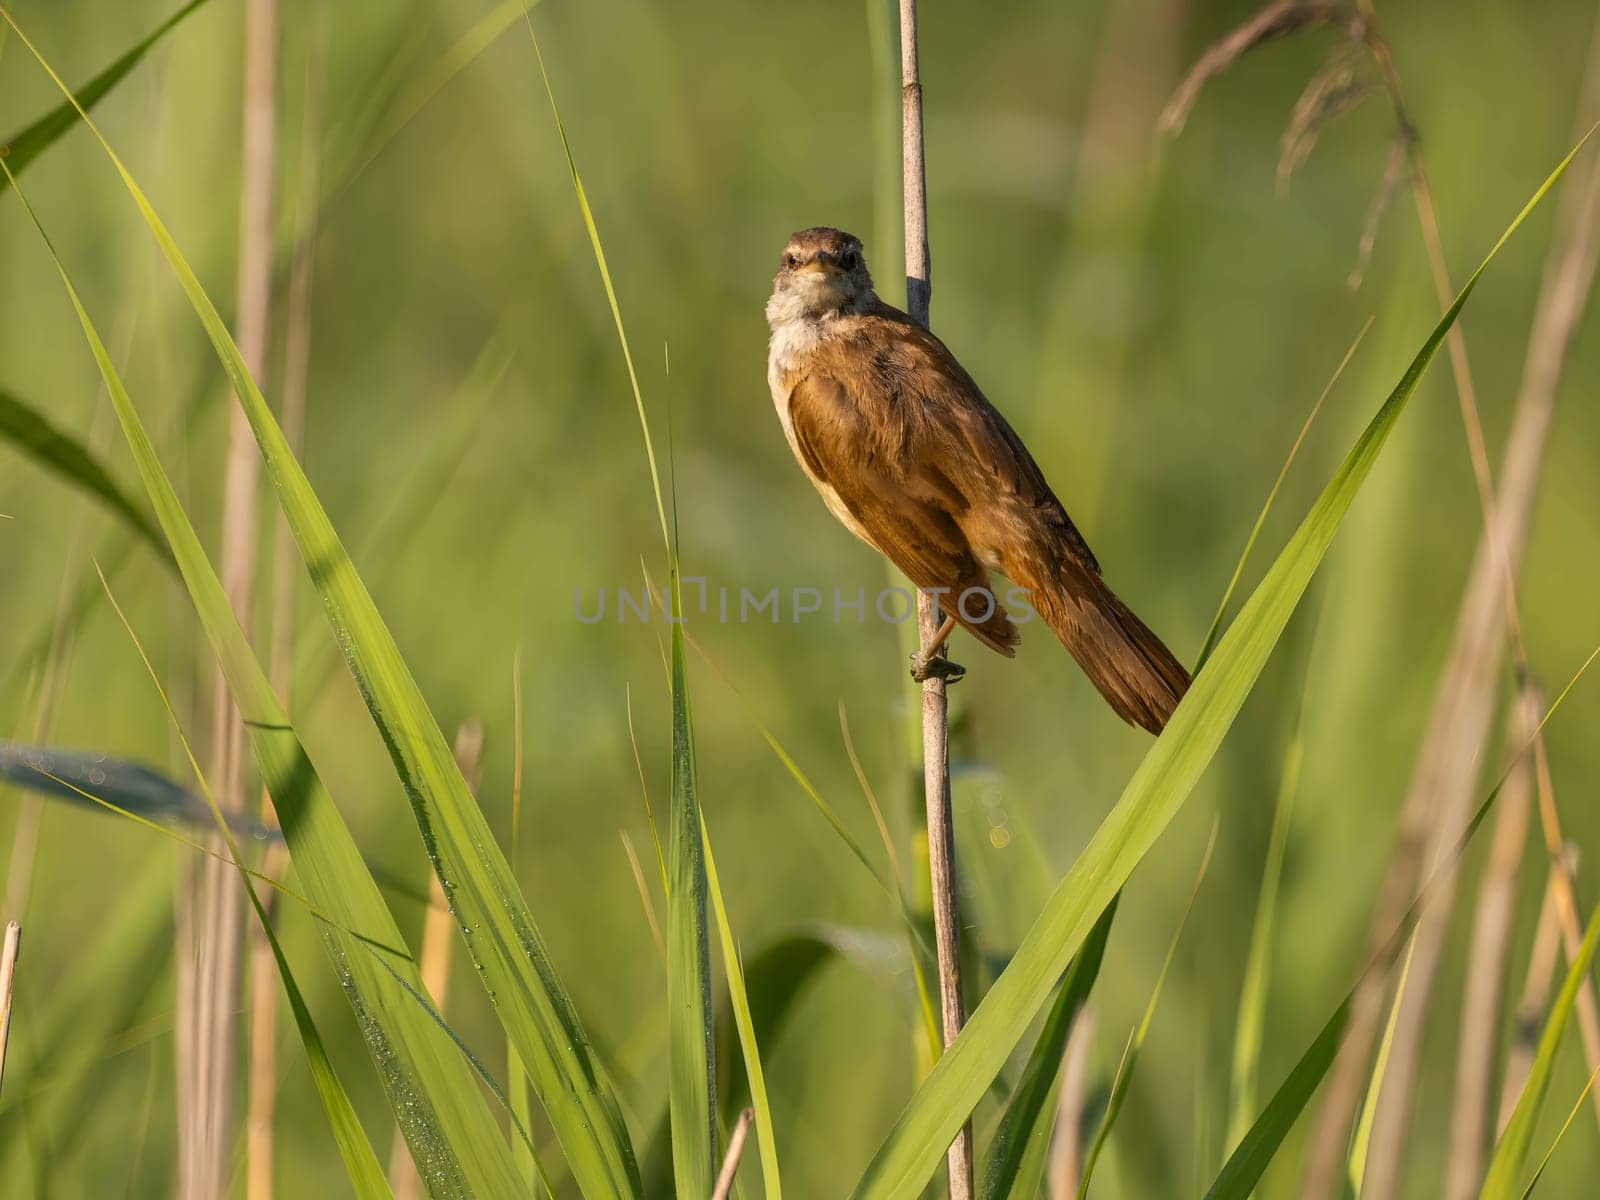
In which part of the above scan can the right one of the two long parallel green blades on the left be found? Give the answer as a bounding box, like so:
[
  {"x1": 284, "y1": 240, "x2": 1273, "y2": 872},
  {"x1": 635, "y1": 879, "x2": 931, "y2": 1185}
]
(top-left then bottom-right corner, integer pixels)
[{"x1": 6, "y1": 18, "x2": 638, "y2": 1195}]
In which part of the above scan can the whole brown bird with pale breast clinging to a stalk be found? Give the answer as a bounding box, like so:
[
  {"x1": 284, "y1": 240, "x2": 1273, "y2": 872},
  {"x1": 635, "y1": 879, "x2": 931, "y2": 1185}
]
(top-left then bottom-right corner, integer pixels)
[{"x1": 766, "y1": 229, "x2": 1189, "y2": 733}]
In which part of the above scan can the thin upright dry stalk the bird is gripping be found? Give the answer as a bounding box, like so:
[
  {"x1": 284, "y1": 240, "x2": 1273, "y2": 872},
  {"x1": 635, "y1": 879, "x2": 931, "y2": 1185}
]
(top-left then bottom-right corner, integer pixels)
[{"x1": 899, "y1": 0, "x2": 973, "y2": 1200}]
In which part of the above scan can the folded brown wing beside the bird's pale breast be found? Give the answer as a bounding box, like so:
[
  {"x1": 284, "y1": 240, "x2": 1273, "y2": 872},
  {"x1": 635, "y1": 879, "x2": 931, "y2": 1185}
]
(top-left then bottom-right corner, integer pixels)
[{"x1": 789, "y1": 371, "x2": 1019, "y2": 656}]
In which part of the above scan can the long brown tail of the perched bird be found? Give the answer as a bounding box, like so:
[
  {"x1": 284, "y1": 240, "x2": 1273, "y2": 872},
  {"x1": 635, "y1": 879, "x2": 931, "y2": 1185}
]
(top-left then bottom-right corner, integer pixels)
[{"x1": 1018, "y1": 558, "x2": 1189, "y2": 733}]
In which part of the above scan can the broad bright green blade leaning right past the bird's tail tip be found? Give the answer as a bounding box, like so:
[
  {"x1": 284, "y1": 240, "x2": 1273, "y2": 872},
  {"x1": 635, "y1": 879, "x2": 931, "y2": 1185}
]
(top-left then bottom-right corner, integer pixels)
[{"x1": 854, "y1": 127, "x2": 1587, "y2": 1200}]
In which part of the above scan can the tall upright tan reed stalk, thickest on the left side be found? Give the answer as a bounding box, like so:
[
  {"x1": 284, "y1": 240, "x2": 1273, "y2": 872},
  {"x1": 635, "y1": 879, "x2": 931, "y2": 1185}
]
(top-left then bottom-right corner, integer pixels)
[{"x1": 178, "y1": 0, "x2": 278, "y2": 1200}]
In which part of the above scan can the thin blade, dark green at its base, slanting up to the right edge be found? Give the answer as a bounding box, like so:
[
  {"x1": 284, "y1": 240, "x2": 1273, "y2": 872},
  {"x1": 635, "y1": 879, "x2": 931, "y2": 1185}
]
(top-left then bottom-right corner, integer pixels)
[{"x1": 1206, "y1": 648, "x2": 1600, "y2": 1200}]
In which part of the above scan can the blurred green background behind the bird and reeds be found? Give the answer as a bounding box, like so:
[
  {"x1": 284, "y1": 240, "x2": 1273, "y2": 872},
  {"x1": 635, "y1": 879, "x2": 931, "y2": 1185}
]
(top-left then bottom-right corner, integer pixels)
[{"x1": 0, "y1": 0, "x2": 1600, "y2": 1198}]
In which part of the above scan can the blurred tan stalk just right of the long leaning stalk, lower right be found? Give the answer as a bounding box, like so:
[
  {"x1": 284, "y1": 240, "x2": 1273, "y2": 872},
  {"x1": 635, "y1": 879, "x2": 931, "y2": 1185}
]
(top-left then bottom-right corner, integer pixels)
[{"x1": 1445, "y1": 686, "x2": 1542, "y2": 1200}]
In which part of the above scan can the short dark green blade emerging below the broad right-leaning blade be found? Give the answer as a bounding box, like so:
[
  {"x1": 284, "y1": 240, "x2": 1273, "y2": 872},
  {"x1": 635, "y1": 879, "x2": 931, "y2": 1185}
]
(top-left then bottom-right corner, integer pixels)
[{"x1": 981, "y1": 896, "x2": 1120, "y2": 1200}]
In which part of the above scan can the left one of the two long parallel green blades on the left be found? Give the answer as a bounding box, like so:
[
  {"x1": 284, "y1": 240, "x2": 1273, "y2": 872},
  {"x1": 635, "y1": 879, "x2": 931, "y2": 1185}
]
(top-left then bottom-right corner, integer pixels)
[{"x1": 0, "y1": 157, "x2": 531, "y2": 1195}]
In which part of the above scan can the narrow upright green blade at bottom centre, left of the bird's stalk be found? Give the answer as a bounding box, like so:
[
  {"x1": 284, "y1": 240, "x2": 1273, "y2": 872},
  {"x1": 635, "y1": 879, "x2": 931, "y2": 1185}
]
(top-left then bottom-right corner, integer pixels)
[{"x1": 667, "y1": 611, "x2": 717, "y2": 1195}]
